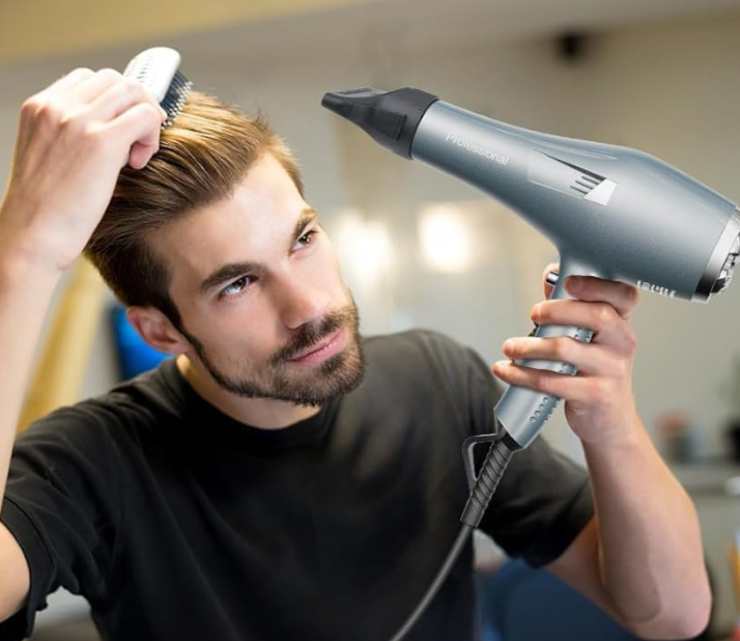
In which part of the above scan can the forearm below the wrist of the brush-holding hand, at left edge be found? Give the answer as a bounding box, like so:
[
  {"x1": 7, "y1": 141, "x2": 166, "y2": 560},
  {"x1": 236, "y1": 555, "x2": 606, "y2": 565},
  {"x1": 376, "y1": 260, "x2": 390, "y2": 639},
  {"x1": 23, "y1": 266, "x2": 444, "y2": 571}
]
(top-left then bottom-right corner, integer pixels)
[{"x1": 0, "y1": 226, "x2": 61, "y2": 500}]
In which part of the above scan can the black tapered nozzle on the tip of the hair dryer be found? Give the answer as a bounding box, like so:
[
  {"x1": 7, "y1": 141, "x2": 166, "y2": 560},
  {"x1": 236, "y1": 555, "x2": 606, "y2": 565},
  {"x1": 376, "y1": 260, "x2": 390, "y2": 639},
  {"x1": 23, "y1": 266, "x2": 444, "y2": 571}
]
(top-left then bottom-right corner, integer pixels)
[{"x1": 321, "y1": 87, "x2": 437, "y2": 158}]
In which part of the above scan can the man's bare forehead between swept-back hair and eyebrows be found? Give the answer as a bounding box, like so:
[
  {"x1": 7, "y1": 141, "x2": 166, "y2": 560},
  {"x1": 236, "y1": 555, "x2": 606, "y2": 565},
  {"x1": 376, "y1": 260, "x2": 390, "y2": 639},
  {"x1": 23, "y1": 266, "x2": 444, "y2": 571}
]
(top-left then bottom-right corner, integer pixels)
[{"x1": 149, "y1": 154, "x2": 306, "y2": 290}]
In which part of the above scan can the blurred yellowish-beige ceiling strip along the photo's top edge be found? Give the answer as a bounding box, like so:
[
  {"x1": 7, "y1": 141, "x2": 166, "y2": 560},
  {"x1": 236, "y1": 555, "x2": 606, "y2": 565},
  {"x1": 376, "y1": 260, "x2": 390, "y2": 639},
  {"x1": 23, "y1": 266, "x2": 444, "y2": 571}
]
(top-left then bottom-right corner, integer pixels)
[{"x1": 0, "y1": 0, "x2": 740, "y2": 66}]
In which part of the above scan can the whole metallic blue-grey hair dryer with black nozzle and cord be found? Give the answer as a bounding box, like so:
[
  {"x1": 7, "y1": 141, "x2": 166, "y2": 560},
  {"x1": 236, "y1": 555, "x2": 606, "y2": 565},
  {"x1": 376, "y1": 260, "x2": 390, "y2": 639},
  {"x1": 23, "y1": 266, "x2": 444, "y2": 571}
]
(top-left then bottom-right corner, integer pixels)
[{"x1": 322, "y1": 88, "x2": 740, "y2": 639}]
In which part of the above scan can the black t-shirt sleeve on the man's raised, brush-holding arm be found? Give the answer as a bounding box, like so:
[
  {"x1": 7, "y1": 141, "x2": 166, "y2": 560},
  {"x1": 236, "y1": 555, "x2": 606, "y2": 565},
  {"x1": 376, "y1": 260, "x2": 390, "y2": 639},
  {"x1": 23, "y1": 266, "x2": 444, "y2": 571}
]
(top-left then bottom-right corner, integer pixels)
[{"x1": 0, "y1": 406, "x2": 121, "y2": 641}]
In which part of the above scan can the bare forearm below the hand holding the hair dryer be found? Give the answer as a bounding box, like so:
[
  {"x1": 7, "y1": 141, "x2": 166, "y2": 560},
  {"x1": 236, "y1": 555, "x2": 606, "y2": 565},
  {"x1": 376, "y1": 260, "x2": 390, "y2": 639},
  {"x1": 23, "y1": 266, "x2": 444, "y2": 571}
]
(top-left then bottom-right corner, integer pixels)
[{"x1": 584, "y1": 414, "x2": 711, "y2": 637}]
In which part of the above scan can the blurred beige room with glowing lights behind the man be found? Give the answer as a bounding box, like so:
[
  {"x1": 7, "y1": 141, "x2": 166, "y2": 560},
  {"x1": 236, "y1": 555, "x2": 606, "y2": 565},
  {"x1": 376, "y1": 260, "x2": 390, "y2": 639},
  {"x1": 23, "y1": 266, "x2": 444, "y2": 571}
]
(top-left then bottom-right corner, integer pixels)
[{"x1": 0, "y1": 0, "x2": 740, "y2": 639}]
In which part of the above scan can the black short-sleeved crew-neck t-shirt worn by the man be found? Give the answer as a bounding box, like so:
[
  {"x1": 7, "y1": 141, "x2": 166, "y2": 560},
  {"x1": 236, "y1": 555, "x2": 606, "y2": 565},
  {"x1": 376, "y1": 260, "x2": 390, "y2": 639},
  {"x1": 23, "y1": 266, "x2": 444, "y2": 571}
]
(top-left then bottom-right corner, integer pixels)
[{"x1": 0, "y1": 330, "x2": 593, "y2": 641}]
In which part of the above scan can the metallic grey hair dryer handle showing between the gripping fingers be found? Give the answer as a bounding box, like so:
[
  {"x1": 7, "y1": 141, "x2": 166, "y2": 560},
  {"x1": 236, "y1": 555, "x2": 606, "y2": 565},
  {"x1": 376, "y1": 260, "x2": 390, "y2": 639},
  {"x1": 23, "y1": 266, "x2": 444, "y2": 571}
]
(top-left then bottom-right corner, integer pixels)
[{"x1": 494, "y1": 256, "x2": 602, "y2": 448}]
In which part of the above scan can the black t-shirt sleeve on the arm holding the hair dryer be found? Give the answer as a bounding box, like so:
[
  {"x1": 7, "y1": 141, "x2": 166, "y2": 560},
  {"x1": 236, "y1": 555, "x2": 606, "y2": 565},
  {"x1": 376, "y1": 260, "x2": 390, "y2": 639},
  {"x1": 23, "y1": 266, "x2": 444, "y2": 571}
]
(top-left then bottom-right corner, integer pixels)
[{"x1": 466, "y1": 340, "x2": 594, "y2": 567}]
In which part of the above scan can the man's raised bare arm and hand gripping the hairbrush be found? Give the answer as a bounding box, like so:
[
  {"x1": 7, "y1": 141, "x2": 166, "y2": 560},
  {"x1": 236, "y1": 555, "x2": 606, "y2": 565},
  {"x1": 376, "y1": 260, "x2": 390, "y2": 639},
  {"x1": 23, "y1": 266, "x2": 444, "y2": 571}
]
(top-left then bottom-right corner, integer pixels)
[{"x1": 0, "y1": 68, "x2": 165, "y2": 621}]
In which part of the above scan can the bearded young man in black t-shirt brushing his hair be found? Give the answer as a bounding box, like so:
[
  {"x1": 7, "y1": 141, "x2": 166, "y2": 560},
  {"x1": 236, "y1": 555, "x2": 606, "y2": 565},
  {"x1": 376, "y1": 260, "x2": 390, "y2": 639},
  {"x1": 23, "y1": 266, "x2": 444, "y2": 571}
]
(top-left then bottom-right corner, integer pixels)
[{"x1": 0, "y1": 69, "x2": 710, "y2": 641}]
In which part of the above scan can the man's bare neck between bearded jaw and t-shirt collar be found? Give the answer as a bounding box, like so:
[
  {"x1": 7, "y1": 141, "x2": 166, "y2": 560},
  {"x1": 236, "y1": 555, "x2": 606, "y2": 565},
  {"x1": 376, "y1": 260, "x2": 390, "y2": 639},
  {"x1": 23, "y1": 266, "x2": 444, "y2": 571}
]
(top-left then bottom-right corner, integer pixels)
[{"x1": 175, "y1": 354, "x2": 320, "y2": 430}]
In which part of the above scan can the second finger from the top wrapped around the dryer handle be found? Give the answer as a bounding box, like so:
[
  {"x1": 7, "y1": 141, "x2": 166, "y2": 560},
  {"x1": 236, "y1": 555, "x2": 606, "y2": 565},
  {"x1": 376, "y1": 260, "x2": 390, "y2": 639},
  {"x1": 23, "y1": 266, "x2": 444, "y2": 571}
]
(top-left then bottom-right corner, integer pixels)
[{"x1": 532, "y1": 299, "x2": 635, "y2": 352}]
